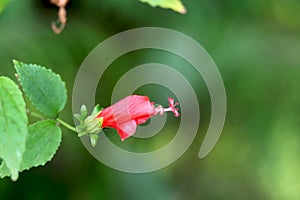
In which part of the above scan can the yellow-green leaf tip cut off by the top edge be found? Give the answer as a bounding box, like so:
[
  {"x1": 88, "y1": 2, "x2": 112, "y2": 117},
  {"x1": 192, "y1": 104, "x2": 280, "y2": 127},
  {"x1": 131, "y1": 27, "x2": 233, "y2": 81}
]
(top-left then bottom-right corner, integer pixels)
[{"x1": 140, "y1": 0, "x2": 186, "y2": 14}]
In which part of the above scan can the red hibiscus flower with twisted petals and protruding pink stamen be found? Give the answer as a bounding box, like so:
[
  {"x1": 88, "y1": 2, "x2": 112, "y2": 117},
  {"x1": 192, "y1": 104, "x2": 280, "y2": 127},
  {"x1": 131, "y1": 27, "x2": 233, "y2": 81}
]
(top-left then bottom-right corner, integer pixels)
[{"x1": 96, "y1": 95, "x2": 179, "y2": 141}]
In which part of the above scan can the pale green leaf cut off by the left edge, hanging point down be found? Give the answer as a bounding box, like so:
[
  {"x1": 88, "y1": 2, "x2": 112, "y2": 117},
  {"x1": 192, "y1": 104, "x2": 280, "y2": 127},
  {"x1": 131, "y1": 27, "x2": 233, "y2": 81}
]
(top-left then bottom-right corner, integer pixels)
[{"x1": 0, "y1": 77, "x2": 28, "y2": 180}]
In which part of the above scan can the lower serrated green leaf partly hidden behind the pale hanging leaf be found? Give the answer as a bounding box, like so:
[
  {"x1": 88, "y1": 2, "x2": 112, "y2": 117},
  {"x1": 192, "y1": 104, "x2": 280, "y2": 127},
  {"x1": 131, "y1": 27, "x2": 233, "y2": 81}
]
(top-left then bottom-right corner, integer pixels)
[{"x1": 0, "y1": 120, "x2": 61, "y2": 178}]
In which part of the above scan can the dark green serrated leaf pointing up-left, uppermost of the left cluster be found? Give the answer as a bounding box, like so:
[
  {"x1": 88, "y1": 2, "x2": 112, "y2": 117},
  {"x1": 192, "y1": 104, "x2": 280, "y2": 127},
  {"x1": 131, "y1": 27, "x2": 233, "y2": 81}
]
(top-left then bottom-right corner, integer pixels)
[{"x1": 13, "y1": 60, "x2": 67, "y2": 117}]
